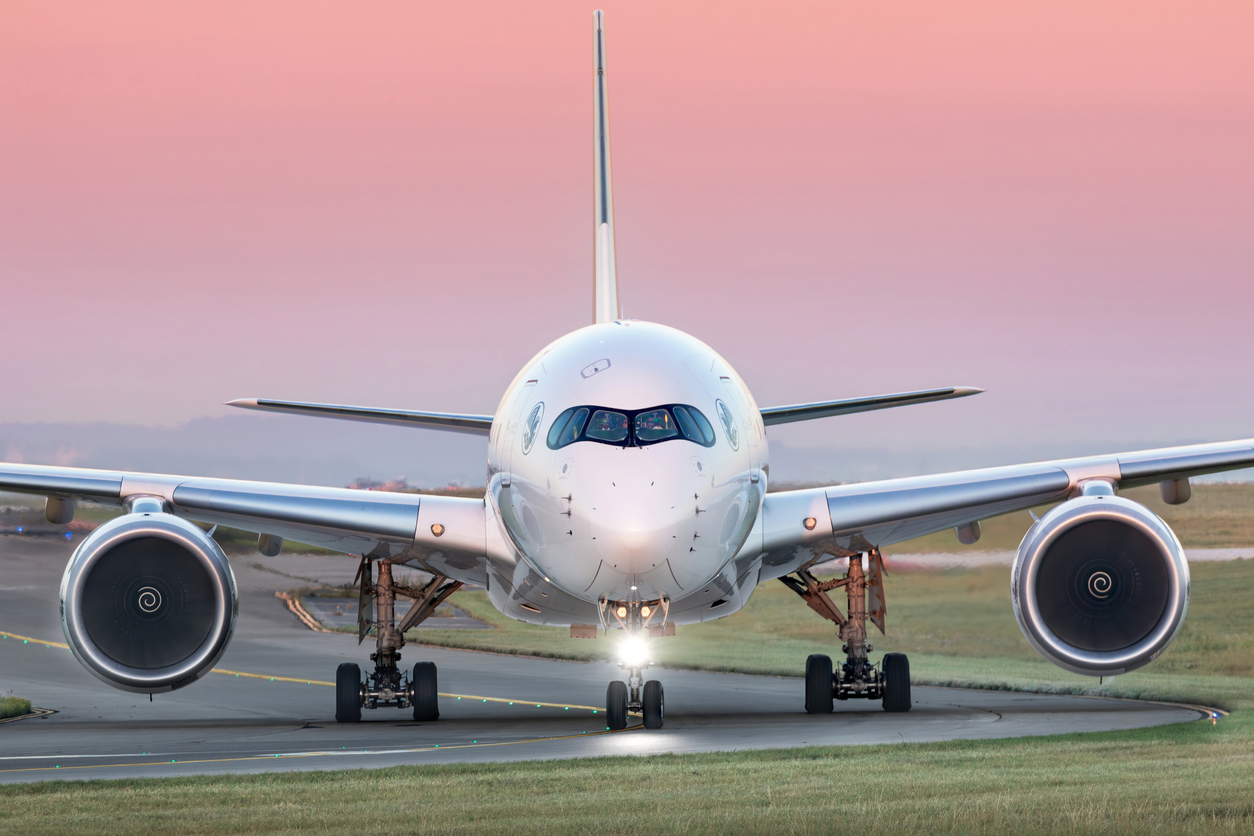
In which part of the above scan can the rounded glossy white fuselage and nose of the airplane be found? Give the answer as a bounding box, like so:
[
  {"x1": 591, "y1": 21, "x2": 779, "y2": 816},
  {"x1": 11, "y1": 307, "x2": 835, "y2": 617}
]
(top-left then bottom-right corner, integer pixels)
[{"x1": 488, "y1": 321, "x2": 767, "y2": 624}]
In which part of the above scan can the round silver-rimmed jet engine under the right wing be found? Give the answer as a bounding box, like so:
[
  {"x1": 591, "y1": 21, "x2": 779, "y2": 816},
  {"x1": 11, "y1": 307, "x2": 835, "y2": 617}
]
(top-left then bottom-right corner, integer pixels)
[{"x1": 1011, "y1": 495, "x2": 1189, "y2": 677}]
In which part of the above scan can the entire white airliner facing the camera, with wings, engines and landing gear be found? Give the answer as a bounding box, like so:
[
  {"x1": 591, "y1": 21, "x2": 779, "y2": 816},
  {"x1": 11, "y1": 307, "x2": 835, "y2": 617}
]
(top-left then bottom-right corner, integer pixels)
[{"x1": 0, "y1": 11, "x2": 1254, "y2": 729}]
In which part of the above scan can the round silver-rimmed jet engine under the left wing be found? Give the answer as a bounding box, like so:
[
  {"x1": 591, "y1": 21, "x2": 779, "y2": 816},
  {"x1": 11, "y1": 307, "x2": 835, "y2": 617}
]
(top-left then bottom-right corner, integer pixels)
[{"x1": 61, "y1": 513, "x2": 238, "y2": 693}]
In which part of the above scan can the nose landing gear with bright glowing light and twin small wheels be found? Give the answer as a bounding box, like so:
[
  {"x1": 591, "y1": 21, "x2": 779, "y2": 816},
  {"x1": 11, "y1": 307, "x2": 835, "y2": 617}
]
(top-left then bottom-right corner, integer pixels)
[{"x1": 599, "y1": 599, "x2": 675, "y2": 731}]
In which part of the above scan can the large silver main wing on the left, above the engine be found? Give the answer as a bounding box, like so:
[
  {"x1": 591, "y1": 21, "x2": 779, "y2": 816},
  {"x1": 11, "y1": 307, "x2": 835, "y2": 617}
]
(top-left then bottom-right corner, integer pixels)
[{"x1": 0, "y1": 462, "x2": 487, "y2": 584}]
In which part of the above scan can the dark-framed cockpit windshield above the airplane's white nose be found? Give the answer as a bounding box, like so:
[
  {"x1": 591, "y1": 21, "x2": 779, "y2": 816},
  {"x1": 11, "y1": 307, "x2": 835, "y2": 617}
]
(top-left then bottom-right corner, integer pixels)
[{"x1": 548, "y1": 404, "x2": 715, "y2": 450}]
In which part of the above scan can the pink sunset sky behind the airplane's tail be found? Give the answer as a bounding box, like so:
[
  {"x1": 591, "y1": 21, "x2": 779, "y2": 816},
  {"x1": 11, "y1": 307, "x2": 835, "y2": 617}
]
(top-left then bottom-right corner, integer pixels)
[{"x1": 0, "y1": 0, "x2": 1254, "y2": 463}]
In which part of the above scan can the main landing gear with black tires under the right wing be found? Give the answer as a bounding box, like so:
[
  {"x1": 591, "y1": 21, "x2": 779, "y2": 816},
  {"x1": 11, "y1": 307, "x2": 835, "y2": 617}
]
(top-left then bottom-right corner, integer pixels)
[{"x1": 780, "y1": 549, "x2": 910, "y2": 714}]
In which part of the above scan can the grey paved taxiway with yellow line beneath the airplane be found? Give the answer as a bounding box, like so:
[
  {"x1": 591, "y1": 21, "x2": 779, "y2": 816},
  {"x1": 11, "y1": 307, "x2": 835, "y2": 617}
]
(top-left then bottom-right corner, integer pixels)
[{"x1": 0, "y1": 535, "x2": 1203, "y2": 783}]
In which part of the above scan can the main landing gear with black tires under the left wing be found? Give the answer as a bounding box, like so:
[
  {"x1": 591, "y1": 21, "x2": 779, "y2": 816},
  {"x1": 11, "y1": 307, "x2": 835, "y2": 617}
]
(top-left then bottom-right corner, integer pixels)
[{"x1": 335, "y1": 556, "x2": 461, "y2": 723}]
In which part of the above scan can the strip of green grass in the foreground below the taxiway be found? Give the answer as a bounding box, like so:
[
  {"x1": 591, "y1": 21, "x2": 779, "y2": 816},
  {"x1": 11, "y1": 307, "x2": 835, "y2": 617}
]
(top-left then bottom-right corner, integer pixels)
[{"x1": 0, "y1": 713, "x2": 1254, "y2": 836}]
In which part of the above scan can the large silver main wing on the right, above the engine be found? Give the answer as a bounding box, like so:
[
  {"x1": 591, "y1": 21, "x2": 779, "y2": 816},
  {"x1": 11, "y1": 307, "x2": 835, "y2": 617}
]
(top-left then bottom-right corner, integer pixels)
[{"x1": 737, "y1": 439, "x2": 1254, "y2": 580}]
